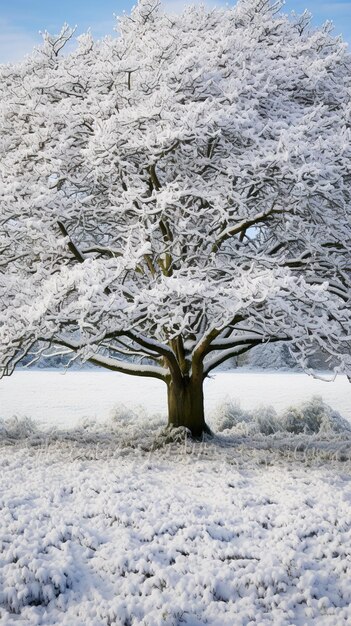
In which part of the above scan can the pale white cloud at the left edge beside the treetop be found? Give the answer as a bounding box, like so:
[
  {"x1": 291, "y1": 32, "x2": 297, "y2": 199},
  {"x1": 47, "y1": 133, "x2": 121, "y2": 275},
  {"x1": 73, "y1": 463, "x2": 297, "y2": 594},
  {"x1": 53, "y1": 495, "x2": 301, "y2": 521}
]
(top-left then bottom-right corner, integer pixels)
[{"x1": 0, "y1": 20, "x2": 41, "y2": 63}]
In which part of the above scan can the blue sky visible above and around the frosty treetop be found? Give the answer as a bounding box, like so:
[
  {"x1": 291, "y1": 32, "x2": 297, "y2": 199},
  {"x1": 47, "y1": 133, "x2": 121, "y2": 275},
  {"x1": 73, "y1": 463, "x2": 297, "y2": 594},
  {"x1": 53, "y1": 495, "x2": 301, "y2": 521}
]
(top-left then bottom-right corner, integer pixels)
[{"x1": 0, "y1": 0, "x2": 351, "y2": 63}]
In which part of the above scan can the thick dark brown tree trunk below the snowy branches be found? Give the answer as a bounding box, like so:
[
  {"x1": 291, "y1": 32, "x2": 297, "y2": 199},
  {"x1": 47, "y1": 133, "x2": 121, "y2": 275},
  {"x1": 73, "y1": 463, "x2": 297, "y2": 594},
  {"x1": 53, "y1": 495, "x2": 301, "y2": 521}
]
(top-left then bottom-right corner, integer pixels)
[{"x1": 167, "y1": 376, "x2": 211, "y2": 439}]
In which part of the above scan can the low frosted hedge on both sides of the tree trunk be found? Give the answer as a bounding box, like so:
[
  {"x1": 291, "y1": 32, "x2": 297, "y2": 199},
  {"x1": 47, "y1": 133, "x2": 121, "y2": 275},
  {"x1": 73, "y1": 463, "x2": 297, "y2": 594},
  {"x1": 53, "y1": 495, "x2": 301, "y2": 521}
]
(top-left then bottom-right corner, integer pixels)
[{"x1": 0, "y1": 396, "x2": 351, "y2": 451}]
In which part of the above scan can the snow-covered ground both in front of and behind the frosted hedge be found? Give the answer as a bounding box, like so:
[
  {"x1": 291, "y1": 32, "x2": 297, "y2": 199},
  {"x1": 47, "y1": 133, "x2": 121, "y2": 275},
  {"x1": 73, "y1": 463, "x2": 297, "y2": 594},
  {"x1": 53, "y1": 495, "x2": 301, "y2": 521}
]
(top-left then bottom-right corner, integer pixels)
[{"x1": 0, "y1": 372, "x2": 351, "y2": 626}]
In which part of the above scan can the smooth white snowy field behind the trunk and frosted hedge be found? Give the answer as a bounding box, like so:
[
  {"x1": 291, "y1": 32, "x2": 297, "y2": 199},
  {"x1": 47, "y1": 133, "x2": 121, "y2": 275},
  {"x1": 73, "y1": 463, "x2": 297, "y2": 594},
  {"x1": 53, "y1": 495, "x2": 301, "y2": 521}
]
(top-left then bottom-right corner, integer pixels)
[{"x1": 0, "y1": 370, "x2": 351, "y2": 427}]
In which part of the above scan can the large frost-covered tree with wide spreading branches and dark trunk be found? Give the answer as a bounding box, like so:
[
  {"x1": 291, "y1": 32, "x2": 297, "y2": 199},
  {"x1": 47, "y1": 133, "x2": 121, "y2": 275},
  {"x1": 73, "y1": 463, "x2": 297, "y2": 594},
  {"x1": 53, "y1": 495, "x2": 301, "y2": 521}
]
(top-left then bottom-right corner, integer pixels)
[{"x1": 0, "y1": 0, "x2": 351, "y2": 436}]
